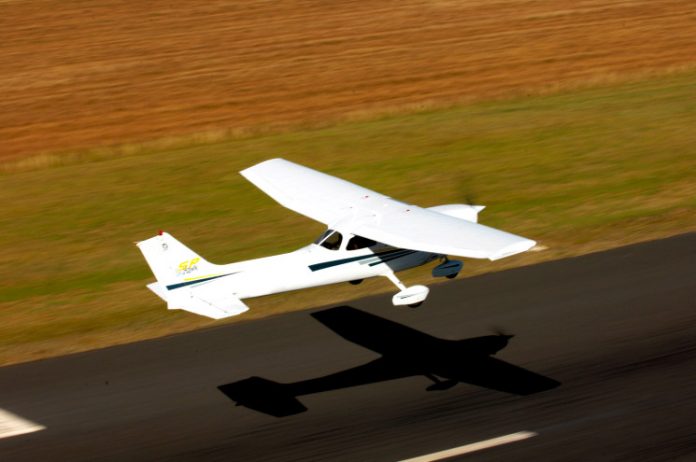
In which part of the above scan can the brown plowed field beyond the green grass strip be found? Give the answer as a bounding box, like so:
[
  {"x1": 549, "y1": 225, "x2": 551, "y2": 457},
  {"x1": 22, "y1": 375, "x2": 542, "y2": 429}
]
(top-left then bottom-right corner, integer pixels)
[{"x1": 0, "y1": 0, "x2": 696, "y2": 159}]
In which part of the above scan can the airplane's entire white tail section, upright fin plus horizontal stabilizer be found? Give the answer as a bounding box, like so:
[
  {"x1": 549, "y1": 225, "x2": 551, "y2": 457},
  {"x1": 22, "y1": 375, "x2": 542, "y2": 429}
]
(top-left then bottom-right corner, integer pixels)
[{"x1": 137, "y1": 233, "x2": 249, "y2": 319}]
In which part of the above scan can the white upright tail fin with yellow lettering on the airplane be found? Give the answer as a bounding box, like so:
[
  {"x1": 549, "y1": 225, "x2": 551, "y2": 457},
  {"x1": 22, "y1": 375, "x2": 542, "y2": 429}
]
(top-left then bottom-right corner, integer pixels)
[{"x1": 136, "y1": 232, "x2": 218, "y2": 288}]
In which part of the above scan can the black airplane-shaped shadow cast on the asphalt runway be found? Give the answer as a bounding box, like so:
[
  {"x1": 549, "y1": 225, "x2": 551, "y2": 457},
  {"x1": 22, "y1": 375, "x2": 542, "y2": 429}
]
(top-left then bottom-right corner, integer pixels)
[{"x1": 218, "y1": 306, "x2": 560, "y2": 417}]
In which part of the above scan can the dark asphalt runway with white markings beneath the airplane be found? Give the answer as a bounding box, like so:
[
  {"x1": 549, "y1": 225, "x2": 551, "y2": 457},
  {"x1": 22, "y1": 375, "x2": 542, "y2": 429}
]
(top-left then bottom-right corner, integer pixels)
[{"x1": 0, "y1": 233, "x2": 696, "y2": 461}]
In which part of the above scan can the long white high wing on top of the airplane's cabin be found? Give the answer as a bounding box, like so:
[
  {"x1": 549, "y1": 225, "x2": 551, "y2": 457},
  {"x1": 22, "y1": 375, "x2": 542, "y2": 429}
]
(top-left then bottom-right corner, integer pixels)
[{"x1": 240, "y1": 159, "x2": 536, "y2": 260}]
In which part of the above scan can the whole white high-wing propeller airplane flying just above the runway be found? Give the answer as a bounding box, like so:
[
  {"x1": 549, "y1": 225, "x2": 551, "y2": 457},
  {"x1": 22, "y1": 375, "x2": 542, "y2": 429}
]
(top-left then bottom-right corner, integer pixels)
[{"x1": 137, "y1": 159, "x2": 536, "y2": 319}]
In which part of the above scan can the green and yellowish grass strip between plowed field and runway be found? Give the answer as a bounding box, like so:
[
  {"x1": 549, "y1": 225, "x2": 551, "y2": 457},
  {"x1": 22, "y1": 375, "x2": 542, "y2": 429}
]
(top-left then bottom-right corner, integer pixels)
[{"x1": 0, "y1": 72, "x2": 696, "y2": 364}]
